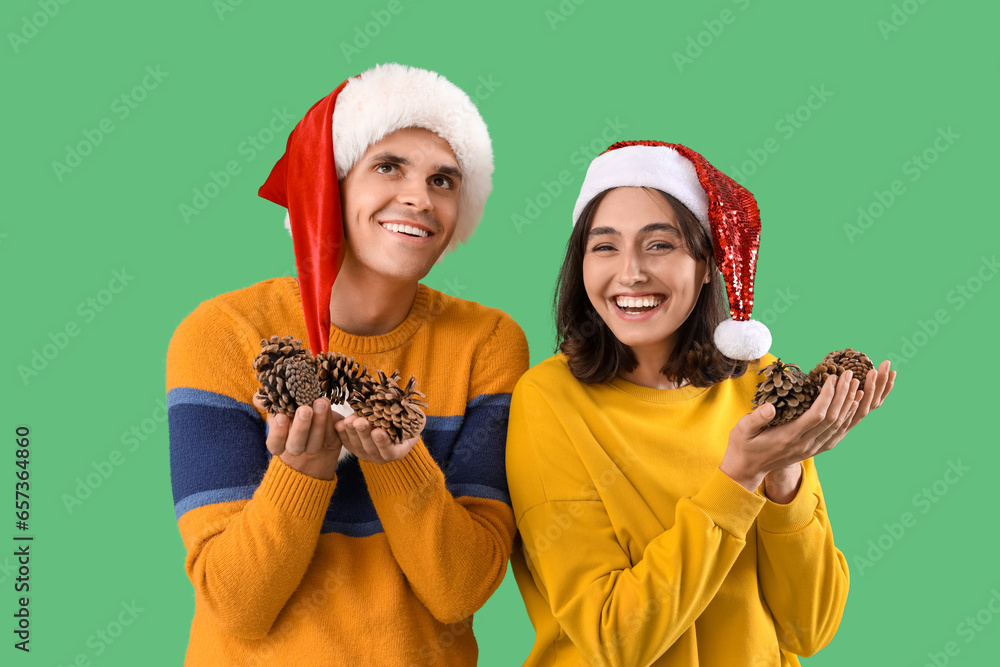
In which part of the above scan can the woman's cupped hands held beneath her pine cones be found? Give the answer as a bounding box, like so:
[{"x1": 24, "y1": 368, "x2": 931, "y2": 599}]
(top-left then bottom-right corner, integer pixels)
[{"x1": 719, "y1": 361, "x2": 896, "y2": 496}]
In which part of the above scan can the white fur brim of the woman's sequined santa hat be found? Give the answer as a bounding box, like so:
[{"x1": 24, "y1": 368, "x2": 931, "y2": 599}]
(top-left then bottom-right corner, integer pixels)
[{"x1": 573, "y1": 146, "x2": 709, "y2": 230}]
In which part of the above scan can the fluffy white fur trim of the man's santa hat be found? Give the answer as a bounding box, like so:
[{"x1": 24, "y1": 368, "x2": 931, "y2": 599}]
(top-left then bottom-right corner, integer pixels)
[{"x1": 333, "y1": 63, "x2": 493, "y2": 251}]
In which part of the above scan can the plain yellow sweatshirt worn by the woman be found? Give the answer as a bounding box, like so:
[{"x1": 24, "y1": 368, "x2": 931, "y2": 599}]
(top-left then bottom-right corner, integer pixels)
[{"x1": 507, "y1": 355, "x2": 849, "y2": 667}]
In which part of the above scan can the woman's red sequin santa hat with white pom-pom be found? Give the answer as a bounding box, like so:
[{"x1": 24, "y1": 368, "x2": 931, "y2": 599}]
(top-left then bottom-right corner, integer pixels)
[{"x1": 573, "y1": 141, "x2": 771, "y2": 360}]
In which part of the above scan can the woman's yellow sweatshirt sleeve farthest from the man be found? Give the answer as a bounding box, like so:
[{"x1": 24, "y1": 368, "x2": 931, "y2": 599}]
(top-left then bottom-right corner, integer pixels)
[{"x1": 757, "y1": 459, "x2": 850, "y2": 656}]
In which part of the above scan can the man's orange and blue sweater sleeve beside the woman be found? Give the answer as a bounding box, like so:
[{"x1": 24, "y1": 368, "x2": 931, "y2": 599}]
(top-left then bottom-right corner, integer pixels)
[{"x1": 360, "y1": 315, "x2": 528, "y2": 623}]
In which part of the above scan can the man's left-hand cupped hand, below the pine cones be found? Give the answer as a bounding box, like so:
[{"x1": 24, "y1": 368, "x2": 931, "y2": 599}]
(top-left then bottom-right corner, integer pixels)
[{"x1": 254, "y1": 395, "x2": 343, "y2": 480}]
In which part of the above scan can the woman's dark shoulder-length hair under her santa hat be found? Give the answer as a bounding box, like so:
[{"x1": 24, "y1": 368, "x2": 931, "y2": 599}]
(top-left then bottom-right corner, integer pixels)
[{"x1": 554, "y1": 188, "x2": 747, "y2": 387}]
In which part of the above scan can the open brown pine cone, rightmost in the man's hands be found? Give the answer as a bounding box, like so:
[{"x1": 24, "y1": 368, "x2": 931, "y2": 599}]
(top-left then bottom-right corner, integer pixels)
[{"x1": 349, "y1": 370, "x2": 427, "y2": 444}]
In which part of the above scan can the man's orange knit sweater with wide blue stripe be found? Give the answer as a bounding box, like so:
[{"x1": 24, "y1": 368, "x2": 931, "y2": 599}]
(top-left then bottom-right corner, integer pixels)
[{"x1": 167, "y1": 278, "x2": 528, "y2": 667}]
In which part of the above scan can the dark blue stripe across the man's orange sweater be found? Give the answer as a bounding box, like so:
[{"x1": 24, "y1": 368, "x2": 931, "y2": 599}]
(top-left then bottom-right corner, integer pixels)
[{"x1": 167, "y1": 387, "x2": 510, "y2": 537}]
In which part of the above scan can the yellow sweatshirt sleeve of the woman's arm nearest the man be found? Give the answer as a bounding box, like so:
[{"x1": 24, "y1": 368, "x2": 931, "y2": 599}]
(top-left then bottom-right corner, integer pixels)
[{"x1": 507, "y1": 383, "x2": 764, "y2": 666}]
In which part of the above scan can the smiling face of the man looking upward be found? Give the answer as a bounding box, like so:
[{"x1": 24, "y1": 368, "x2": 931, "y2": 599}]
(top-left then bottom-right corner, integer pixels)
[{"x1": 340, "y1": 128, "x2": 462, "y2": 281}]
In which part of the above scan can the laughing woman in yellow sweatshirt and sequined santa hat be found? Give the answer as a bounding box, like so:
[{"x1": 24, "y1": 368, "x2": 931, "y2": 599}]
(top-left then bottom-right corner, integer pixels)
[{"x1": 507, "y1": 142, "x2": 895, "y2": 667}]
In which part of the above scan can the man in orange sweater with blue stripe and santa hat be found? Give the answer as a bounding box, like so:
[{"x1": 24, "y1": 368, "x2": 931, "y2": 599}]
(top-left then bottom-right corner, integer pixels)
[{"x1": 167, "y1": 65, "x2": 528, "y2": 667}]
